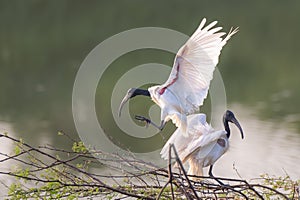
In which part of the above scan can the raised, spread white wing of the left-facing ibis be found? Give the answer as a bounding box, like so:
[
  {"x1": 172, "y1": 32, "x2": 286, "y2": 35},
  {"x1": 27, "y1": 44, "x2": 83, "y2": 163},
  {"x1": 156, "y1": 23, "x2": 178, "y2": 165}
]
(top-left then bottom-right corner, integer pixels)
[{"x1": 160, "y1": 18, "x2": 238, "y2": 114}]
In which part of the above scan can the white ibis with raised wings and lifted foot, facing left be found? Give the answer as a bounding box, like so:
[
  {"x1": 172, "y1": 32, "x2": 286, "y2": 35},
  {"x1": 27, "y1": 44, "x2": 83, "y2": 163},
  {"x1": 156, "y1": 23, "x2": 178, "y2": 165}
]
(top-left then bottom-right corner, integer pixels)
[{"x1": 119, "y1": 18, "x2": 238, "y2": 134}]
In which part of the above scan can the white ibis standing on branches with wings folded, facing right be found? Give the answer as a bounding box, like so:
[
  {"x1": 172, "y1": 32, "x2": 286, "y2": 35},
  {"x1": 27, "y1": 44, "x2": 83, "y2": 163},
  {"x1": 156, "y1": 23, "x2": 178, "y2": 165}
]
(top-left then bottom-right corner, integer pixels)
[{"x1": 160, "y1": 110, "x2": 244, "y2": 184}]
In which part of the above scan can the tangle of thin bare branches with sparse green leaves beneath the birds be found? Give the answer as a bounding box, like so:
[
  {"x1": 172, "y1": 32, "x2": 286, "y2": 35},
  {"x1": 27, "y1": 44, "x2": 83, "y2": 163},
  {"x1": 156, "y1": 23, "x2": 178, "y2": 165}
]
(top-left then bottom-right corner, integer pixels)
[{"x1": 0, "y1": 132, "x2": 300, "y2": 199}]
